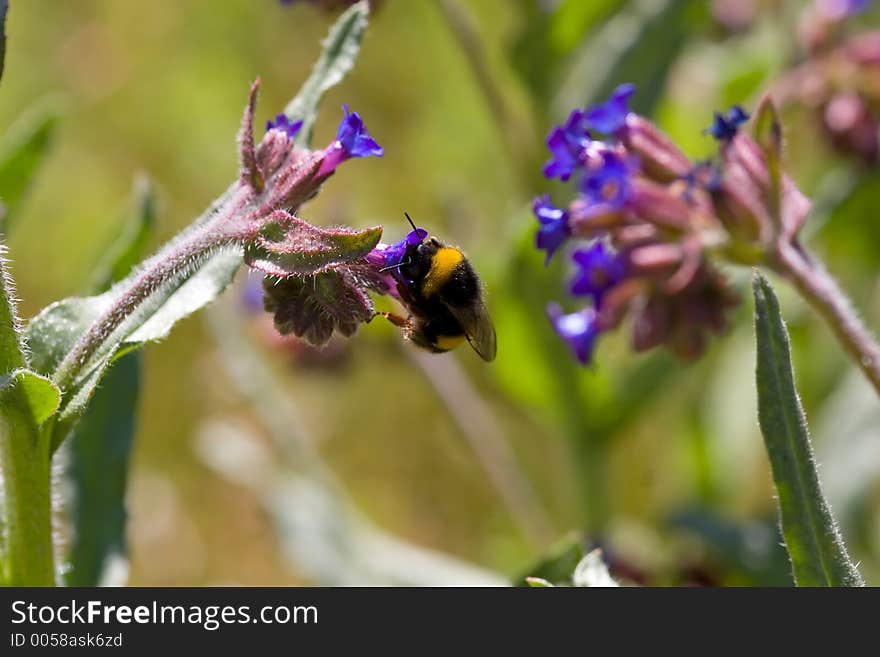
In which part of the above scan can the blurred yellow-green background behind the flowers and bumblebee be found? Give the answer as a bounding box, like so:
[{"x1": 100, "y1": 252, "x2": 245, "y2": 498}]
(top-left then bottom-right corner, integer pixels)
[{"x1": 0, "y1": 0, "x2": 880, "y2": 585}]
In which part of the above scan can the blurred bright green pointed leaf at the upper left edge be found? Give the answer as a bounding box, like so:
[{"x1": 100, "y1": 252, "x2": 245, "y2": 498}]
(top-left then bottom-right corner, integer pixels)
[{"x1": 0, "y1": 102, "x2": 58, "y2": 234}]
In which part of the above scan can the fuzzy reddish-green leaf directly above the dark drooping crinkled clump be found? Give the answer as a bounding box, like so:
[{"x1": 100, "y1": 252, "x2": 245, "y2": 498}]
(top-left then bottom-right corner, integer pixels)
[{"x1": 245, "y1": 211, "x2": 382, "y2": 277}]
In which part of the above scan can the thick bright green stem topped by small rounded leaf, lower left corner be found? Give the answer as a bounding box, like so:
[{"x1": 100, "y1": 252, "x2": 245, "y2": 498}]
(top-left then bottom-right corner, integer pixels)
[{"x1": 0, "y1": 369, "x2": 61, "y2": 586}]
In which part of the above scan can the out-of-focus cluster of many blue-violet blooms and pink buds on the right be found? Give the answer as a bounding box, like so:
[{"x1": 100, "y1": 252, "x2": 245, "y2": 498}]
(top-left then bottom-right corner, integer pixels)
[{"x1": 533, "y1": 84, "x2": 808, "y2": 364}]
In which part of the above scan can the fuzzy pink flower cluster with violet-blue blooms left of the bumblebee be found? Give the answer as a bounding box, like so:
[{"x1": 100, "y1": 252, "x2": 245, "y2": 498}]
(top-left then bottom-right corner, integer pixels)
[{"x1": 233, "y1": 80, "x2": 387, "y2": 345}]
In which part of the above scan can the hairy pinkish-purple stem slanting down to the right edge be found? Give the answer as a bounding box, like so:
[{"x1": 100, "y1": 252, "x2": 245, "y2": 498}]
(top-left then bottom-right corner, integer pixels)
[{"x1": 775, "y1": 245, "x2": 880, "y2": 394}]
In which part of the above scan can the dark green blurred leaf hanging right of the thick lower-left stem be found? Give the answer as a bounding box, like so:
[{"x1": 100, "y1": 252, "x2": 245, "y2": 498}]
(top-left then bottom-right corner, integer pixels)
[{"x1": 65, "y1": 353, "x2": 141, "y2": 586}]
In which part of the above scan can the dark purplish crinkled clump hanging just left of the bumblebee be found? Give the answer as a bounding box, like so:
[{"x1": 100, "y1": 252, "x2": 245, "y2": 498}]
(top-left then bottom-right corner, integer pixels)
[{"x1": 263, "y1": 268, "x2": 374, "y2": 346}]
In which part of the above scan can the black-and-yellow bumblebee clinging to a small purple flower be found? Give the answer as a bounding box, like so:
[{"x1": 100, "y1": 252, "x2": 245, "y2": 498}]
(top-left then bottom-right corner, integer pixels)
[{"x1": 380, "y1": 213, "x2": 496, "y2": 362}]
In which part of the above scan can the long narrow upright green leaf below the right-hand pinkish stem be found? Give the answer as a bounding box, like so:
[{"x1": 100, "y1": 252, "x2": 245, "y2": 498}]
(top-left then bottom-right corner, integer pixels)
[{"x1": 753, "y1": 273, "x2": 864, "y2": 586}]
